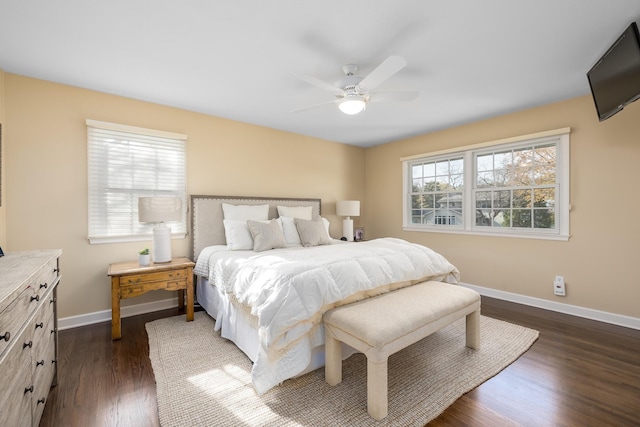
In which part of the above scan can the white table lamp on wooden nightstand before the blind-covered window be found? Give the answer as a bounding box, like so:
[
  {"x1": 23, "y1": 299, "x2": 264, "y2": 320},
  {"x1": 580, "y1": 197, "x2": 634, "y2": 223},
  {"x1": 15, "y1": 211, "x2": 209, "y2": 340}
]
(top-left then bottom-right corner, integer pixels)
[{"x1": 138, "y1": 197, "x2": 182, "y2": 263}]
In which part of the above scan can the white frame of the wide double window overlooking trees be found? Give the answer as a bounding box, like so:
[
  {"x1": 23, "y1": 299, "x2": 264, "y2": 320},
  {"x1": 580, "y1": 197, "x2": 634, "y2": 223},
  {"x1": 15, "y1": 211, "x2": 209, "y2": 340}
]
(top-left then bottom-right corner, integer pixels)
[{"x1": 400, "y1": 128, "x2": 571, "y2": 241}]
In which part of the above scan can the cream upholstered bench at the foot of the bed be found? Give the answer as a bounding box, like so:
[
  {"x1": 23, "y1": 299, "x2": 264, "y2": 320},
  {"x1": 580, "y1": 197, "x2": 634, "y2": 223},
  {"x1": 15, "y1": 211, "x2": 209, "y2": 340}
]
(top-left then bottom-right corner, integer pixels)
[{"x1": 323, "y1": 282, "x2": 480, "y2": 420}]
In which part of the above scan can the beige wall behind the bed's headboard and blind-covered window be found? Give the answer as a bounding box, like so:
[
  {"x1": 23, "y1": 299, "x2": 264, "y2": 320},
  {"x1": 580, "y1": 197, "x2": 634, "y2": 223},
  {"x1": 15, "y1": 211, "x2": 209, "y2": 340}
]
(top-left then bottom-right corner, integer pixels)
[{"x1": 0, "y1": 73, "x2": 364, "y2": 317}]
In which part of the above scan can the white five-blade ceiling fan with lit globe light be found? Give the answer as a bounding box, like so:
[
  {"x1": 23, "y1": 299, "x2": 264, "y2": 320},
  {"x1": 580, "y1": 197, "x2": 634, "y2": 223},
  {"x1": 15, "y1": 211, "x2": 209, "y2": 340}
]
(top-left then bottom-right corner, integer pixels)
[{"x1": 294, "y1": 56, "x2": 418, "y2": 115}]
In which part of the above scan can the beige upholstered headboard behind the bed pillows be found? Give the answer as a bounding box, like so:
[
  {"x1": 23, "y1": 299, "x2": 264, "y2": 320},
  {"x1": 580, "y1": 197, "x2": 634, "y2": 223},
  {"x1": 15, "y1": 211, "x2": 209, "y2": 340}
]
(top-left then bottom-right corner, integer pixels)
[{"x1": 191, "y1": 195, "x2": 321, "y2": 261}]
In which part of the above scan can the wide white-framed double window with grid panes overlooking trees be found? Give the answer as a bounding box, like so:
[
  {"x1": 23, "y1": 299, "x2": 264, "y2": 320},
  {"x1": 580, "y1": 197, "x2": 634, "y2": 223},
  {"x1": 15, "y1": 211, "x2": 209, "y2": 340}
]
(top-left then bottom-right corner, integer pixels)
[{"x1": 402, "y1": 129, "x2": 569, "y2": 240}]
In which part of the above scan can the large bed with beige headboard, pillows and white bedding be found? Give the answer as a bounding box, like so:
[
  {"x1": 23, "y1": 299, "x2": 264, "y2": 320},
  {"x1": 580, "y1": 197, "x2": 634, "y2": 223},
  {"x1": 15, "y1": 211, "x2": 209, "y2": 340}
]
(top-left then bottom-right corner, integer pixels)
[{"x1": 191, "y1": 195, "x2": 459, "y2": 393}]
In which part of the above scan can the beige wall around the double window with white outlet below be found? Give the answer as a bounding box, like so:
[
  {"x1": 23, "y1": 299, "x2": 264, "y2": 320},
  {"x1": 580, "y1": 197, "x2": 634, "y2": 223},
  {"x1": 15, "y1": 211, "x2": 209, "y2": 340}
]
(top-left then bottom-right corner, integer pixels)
[{"x1": 363, "y1": 96, "x2": 640, "y2": 317}]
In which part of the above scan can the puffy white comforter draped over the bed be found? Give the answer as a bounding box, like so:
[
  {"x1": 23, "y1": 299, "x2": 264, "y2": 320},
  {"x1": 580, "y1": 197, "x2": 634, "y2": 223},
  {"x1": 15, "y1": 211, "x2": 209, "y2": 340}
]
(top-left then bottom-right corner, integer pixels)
[{"x1": 195, "y1": 238, "x2": 459, "y2": 393}]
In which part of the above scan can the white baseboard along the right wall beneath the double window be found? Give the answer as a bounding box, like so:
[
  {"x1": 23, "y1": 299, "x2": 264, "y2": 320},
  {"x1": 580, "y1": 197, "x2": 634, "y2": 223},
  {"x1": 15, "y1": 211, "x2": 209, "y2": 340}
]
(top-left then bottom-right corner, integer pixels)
[{"x1": 461, "y1": 283, "x2": 640, "y2": 330}]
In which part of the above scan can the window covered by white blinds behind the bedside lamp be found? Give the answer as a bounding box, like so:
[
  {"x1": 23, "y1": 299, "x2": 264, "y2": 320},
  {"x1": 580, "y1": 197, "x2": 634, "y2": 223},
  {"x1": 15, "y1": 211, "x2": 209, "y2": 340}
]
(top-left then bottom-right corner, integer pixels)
[{"x1": 87, "y1": 120, "x2": 187, "y2": 243}]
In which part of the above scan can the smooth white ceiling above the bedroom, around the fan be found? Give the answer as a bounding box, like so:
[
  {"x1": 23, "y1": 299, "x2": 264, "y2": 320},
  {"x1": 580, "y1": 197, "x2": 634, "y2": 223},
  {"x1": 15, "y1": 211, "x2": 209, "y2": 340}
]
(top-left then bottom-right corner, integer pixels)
[{"x1": 0, "y1": 0, "x2": 640, "y2": 147}]
